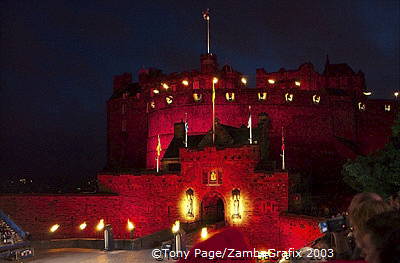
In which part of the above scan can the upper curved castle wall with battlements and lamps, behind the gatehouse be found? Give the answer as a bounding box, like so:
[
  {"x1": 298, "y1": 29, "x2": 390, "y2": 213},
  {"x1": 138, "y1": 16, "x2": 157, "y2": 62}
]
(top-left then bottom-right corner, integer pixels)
[{"x1": 108, "y1": 54, "x2": 399, "y2": 173}]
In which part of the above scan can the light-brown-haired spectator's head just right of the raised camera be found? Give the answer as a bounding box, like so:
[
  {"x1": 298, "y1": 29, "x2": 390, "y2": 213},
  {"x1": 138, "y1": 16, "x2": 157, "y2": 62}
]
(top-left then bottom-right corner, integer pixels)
[{"x1": 349, "y1": 200, "x2": 391, "y2": 238}]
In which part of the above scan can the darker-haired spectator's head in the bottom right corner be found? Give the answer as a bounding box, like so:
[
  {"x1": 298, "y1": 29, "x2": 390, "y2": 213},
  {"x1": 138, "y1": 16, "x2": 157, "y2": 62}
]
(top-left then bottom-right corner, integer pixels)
[{"x1": 360, "y1": 211, "x2": 400, "y2": 263}]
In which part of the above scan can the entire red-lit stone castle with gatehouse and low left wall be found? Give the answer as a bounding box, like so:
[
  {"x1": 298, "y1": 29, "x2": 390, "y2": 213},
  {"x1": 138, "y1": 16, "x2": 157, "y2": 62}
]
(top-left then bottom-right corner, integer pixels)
[{"x1": 0, "y1": 54, "x2": 396, "y2": 252}]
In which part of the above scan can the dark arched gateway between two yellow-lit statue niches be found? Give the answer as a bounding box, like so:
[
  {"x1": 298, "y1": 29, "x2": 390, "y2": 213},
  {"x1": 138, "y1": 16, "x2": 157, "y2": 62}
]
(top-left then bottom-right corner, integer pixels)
[{"x1": 201, "y1": 192, "x2": 225, "y2": 224}]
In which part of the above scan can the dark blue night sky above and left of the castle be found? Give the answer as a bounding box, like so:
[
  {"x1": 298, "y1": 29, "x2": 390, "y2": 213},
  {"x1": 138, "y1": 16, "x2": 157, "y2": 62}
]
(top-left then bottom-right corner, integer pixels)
[{"x1": 0, "y1": 0, "x2": 400, "y2": 189}]
